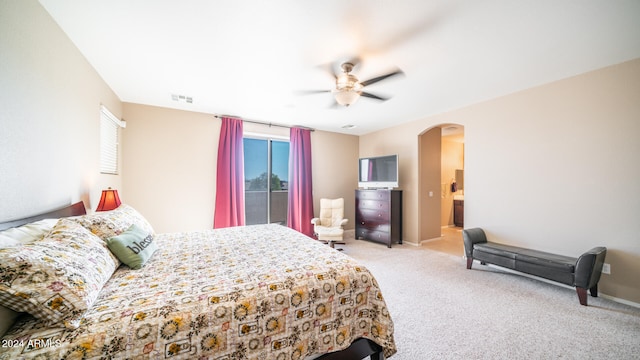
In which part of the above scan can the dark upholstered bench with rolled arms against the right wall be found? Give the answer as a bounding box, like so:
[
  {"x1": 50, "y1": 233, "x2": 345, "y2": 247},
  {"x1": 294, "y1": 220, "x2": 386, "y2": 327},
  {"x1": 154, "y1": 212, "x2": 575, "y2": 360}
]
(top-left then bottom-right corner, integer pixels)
[{"x1": 462, "y1": 228, "x2": 607, "y2": 306}]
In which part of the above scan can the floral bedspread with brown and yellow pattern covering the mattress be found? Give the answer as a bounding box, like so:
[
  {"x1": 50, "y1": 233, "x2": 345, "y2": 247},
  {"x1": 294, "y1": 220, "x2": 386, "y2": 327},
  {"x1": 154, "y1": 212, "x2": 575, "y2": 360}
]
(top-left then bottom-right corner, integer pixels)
[{"x1": 0, "y1": 225, "x2": 396, "y2": 360}]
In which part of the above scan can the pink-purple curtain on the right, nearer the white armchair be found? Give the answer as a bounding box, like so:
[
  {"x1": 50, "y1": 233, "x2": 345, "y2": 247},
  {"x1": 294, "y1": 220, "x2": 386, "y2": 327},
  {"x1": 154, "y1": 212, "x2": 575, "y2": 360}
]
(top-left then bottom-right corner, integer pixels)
[{"x1": 287, "y1": 128, "x2": 313, "y2": 236}]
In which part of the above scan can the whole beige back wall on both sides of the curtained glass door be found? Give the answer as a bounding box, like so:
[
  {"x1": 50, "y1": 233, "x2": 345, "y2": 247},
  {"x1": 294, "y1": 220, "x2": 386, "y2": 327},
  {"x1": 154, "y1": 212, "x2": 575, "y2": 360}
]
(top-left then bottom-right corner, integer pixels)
[{"x1": 121, "y1": 103, "x2": 358, "y2": 233}]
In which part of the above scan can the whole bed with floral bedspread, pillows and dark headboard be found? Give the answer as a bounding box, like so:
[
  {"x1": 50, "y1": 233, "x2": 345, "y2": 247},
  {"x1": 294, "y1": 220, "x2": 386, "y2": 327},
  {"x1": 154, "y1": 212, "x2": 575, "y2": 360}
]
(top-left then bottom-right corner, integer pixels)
[{"x1": 0, "y1": 203, "x2": 396, "y2": 360}]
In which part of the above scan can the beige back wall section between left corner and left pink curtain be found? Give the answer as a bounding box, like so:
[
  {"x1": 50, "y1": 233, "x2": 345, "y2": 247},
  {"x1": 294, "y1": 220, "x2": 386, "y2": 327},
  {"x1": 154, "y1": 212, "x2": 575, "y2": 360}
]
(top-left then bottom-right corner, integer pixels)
[{"x1": 120, "y1": 103, "x2": 220, "y2": 233}]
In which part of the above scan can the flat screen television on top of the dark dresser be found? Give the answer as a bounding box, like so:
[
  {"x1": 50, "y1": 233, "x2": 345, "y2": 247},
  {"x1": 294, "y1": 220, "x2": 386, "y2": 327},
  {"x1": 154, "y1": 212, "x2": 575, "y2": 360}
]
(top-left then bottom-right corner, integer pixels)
[{"x1": 358, "y1": 155, "x2": 398, "y2": 189}]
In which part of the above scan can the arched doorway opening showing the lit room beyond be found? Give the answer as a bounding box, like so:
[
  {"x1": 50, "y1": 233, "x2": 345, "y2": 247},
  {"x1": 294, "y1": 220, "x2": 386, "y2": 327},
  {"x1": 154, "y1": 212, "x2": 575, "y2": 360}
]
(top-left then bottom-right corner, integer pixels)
[{"x1": 418, "y1": 124, "x2": 464, "y2": 252}]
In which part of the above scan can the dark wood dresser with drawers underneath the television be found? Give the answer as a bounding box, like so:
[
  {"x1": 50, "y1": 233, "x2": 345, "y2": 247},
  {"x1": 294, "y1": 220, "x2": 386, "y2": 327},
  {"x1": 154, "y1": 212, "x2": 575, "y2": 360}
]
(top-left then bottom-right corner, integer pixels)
[{"x1": 356, "y1": 189, "x2": 402, "y2": 247}]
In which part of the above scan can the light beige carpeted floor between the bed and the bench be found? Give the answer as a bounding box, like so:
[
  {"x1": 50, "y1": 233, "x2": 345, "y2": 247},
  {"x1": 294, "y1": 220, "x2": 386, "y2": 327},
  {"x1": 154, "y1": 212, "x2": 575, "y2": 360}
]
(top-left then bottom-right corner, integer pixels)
[{"x1": 339, "y1": 239, "x2": 640, "y2": 360}]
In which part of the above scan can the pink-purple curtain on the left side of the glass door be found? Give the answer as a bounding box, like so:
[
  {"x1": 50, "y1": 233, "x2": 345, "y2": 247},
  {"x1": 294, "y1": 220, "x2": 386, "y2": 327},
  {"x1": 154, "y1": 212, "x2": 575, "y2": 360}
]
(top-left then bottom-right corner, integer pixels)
[{"x1": 213, "y1": 117, "x2": 244, "y2": 229}]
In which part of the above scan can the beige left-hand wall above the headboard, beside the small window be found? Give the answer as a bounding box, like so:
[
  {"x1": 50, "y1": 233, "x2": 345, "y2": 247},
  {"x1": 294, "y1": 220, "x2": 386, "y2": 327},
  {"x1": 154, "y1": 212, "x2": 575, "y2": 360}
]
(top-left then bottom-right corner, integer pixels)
[{"x1": 0, "y1": 0, "x2": 122, "y2": 220}]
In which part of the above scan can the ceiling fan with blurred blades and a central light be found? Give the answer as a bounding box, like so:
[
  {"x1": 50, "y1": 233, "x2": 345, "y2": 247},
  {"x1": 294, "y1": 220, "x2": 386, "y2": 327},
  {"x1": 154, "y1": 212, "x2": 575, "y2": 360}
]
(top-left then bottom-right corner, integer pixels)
[{"x1": 303, "y1": 60, "x2": 404, "y2": 106}]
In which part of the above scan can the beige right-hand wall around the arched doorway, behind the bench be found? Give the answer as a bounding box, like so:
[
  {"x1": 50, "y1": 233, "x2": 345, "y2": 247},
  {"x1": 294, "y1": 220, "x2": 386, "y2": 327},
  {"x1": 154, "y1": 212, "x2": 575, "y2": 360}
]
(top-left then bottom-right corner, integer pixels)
[{"x1": 360, "y1": 59, "x2": 640, "y2": 303}]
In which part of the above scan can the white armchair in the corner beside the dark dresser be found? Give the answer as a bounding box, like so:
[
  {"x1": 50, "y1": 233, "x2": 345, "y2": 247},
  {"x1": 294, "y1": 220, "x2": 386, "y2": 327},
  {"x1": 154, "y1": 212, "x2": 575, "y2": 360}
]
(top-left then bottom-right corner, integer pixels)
[{"x1": 311, "y1": 198, "x2": 349, "y2": 247}]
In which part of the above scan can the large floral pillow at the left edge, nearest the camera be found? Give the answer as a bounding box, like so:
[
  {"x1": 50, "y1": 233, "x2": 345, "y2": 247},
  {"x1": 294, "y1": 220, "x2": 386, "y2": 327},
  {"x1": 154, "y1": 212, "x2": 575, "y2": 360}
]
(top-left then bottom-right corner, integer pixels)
[{"x1": 0, "y1": 218, "x2": 119, "y2": 329}]
